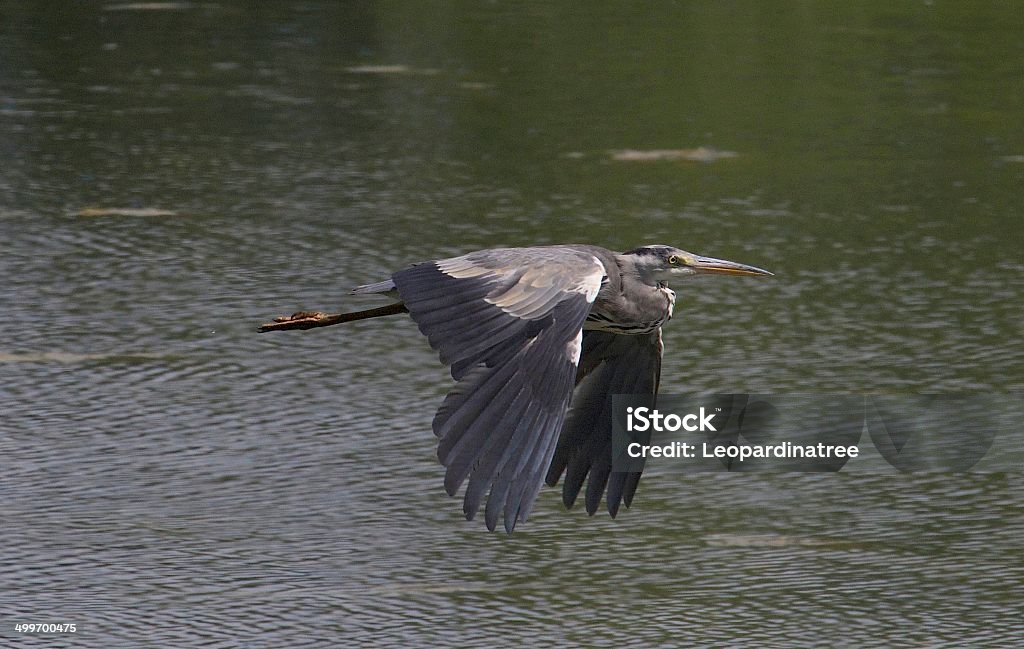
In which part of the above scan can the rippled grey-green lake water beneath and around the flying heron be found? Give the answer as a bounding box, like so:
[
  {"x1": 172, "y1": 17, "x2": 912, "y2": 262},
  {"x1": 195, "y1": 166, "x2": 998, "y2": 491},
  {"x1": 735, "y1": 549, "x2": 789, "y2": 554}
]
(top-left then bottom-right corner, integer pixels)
[{"x1": 0, "y1": 0, "x2": 1024, "y2": 647}]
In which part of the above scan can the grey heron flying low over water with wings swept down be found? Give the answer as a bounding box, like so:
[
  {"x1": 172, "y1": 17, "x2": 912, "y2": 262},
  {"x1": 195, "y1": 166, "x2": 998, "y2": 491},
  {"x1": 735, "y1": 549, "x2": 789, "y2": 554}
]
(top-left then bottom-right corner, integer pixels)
[{"x1": 261, "y1": 245, "x2": 772, "y2": 533}]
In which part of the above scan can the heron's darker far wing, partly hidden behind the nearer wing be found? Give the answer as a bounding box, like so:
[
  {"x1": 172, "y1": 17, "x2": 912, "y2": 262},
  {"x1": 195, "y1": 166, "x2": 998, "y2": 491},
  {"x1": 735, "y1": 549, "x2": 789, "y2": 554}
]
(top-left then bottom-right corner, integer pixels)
[{"x1": 547, "y1": 328, "x2": 664, "y2": 516}]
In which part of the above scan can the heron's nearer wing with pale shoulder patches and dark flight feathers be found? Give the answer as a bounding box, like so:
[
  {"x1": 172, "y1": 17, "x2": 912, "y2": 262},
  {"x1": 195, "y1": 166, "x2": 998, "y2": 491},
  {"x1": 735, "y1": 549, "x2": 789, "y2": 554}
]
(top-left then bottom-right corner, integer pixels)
[{"x1": 392, "y1": 247, "x2": 605, "y2": 532}]
